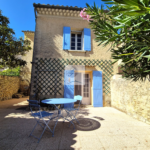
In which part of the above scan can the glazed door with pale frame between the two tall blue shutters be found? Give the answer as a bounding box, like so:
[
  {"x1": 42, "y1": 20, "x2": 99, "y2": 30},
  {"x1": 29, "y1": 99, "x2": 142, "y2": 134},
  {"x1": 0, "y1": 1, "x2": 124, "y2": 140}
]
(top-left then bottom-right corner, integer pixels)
[{"x1": 74, "y1": 72, "x2": 91, "y2": 105}]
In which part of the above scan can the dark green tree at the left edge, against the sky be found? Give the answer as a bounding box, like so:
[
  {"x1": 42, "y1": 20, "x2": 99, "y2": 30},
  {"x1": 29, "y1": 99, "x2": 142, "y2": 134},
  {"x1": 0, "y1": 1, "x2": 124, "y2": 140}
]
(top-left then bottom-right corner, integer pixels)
[{"x1": 0, "y1": 10, "x2": 31, "y2": 68}]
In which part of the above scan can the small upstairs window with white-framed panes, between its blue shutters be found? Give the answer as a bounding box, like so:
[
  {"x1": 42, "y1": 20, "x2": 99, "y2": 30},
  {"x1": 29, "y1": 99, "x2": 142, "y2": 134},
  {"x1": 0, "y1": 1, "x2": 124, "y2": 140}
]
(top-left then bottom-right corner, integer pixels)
[{"x1": 71, "y1": 32, "x2": 83, "y2": 50}]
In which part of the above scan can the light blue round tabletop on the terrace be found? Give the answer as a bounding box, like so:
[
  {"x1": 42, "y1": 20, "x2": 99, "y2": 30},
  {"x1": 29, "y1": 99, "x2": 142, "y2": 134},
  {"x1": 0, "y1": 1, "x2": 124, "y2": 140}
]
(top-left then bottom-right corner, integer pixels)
[{"x1": 42, "y1": 98, "x2": 77, "y2": 105}]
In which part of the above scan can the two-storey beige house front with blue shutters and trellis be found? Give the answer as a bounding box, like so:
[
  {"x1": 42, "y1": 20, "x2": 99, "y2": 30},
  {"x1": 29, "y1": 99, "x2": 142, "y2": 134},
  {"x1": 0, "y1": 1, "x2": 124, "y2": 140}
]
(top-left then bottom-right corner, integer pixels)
[{"x1": 30, "y1": 4, "x2": 118, "y2": 107}]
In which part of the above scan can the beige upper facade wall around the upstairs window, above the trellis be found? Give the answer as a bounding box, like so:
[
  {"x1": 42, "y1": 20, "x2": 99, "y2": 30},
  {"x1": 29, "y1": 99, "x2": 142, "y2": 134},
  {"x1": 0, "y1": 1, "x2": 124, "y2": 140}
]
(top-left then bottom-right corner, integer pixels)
[{"x1": 34, "y1": 15, "x2": 111, "y2": 60}]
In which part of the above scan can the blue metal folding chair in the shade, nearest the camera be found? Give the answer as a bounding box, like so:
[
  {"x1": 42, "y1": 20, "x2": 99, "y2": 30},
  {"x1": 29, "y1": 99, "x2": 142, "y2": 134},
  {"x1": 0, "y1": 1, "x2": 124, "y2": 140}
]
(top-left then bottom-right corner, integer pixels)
[{"x1": 27, "y1": 100, "x2": 58, "y2": 143}]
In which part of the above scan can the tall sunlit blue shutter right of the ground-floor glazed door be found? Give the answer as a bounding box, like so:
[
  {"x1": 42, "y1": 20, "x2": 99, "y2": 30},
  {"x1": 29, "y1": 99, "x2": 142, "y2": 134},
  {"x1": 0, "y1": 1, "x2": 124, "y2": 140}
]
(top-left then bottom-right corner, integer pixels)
[{"x1": 93, "y1": 71, "x2": 103, "y2": 107}]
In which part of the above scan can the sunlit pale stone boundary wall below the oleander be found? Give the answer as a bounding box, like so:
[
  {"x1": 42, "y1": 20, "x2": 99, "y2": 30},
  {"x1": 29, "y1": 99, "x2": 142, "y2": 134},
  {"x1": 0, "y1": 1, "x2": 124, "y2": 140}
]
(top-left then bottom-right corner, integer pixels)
[{"x1": 111, "y1": 78, "x2": 150, "y2": 124}]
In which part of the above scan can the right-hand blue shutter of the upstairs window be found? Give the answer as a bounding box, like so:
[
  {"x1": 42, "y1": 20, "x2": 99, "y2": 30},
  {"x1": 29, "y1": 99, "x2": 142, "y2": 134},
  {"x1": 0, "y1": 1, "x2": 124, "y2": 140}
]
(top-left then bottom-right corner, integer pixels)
[{"x1": 84, "y1": 28, "x2": 91, "y2": 51}]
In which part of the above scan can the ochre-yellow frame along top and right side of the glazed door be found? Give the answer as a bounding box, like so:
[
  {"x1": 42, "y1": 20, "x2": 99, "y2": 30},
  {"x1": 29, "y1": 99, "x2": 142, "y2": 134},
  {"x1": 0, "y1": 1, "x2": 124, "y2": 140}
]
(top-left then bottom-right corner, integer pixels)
[{"x1": 74, "y1": 70, "x2": 93, "y2": 106}]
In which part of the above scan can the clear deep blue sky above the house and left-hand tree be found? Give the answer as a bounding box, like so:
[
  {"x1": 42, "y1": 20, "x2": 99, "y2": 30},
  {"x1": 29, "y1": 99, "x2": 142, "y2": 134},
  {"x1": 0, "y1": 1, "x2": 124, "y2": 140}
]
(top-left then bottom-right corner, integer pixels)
[{"x1": 0, "y1": 0, "x2": 104, "y2": 38}]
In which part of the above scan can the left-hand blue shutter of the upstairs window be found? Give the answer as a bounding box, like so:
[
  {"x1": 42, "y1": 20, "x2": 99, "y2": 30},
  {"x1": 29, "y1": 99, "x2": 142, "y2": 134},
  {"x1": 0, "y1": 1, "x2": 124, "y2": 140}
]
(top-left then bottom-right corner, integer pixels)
[{"x1": 63, "y1": 27, "x2": 71, "y2": 50}]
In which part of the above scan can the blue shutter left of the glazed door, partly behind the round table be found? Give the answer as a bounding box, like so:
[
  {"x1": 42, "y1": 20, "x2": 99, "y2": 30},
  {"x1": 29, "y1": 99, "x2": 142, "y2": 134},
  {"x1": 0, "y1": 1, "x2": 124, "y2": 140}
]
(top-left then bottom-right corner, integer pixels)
[{"x1": 64, "y1": 70, "x2": 74, "y2": 108}]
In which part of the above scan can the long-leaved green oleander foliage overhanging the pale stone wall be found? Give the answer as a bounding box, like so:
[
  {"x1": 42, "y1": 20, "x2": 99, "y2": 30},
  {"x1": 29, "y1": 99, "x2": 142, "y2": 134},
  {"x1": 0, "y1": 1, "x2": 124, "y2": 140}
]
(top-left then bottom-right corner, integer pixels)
[{"x1": 82, "y1": 0, "x2": 150, "y2": 81}]
